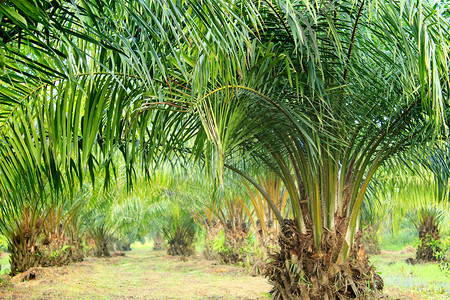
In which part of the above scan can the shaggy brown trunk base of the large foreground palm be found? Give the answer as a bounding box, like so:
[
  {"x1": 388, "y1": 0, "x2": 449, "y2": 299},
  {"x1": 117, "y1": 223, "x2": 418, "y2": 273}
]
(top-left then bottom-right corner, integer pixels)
[{"x1": 265, "y1": 220, "x2": 383, "y2": 300}]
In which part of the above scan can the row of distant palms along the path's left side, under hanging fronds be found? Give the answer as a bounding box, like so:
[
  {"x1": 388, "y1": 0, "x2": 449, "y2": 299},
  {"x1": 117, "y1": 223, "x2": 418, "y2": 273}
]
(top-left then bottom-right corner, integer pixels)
[{"x1": 0, "y1": 161, "x2": 212, "y2": 276}]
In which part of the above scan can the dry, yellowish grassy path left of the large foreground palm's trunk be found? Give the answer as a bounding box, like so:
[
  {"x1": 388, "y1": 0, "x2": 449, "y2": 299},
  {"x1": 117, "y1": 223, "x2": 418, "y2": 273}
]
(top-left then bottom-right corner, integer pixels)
[{"x1": 0, "y1": 250, "x2": 271, "y2": 299}]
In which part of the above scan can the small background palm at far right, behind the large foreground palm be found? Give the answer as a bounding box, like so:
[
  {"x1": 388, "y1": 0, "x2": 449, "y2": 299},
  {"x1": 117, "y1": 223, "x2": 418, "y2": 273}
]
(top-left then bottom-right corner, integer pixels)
[{"x1": 371, "y1": 156, "x2": 448, "y2": 262}]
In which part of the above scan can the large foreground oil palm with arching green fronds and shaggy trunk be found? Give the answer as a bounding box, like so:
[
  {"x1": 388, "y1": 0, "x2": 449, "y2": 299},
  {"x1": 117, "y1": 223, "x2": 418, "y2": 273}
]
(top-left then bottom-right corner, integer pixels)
[{"x1": 188, "y1": 2, "x2": 448, "y2": 299}]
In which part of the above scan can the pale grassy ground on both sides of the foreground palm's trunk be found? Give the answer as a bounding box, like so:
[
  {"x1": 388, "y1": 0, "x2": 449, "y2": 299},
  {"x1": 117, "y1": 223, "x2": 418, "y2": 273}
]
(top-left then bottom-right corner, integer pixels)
[{"x1": 0, "y1": 245, "x2": 450, "y2": 300}]
